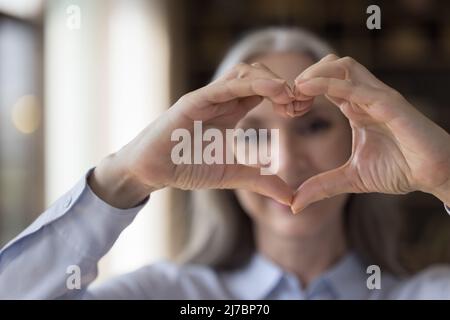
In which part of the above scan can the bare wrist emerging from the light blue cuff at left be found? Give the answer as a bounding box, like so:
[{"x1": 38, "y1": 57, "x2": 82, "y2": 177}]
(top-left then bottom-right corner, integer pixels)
[{"x1": 88, "y1": 154, "x2": 157, "y2": 209}]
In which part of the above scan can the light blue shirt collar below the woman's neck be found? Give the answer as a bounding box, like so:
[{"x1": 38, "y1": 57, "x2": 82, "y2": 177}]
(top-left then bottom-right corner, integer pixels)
[{"x1": 223, "y1": 252, "x2": 371, "y2": 300}]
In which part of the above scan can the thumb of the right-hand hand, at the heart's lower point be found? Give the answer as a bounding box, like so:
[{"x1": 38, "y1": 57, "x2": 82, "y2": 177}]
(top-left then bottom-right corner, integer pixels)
[{"x1": 291, "y1": 166, "x2": 355, "y2": 213}]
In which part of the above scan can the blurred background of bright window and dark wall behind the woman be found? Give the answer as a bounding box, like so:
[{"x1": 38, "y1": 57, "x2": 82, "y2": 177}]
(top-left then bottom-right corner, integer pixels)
[{"x1": 0, "y1": 0, "x2": 450, "y2": 281}]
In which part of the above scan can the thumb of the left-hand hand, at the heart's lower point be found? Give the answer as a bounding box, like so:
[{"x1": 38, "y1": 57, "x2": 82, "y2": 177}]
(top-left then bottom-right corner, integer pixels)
[{"x1": 225, "y1": 164, "x2": 293, "y2": 206}]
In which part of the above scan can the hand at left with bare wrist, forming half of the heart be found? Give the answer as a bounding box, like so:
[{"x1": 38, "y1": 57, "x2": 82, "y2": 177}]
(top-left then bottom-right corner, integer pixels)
[{"x1": 89, "y1": 63, "x2": 294, "y2": 208}]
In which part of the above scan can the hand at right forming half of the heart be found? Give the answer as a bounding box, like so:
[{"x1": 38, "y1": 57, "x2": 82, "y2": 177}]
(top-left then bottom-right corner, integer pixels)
[{"x1": 292, "y1": 55, "x2": 450, "y2": 213}]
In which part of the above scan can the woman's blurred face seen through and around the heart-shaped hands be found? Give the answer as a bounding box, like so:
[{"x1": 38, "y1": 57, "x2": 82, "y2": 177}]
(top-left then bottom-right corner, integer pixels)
[{"x1": 235, "y1": 53, "x2": 352, "y2": 237}]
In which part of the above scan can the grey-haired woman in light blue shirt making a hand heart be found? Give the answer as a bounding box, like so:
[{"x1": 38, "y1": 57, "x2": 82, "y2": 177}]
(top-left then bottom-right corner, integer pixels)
[{"x1": 0, "y1": 29, "x2": 450, "y2": 299}]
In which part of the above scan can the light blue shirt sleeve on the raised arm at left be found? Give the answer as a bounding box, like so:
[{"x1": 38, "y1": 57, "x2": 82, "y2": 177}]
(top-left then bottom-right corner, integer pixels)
[{"x1": 0, "y1": 170, "x2": 148, "y2": 299}]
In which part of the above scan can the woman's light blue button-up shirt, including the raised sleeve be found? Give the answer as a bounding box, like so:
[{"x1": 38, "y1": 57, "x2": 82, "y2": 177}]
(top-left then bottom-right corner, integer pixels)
[{"x1": 0, "y1": 173, "x2": 450, "y2": 299}]
